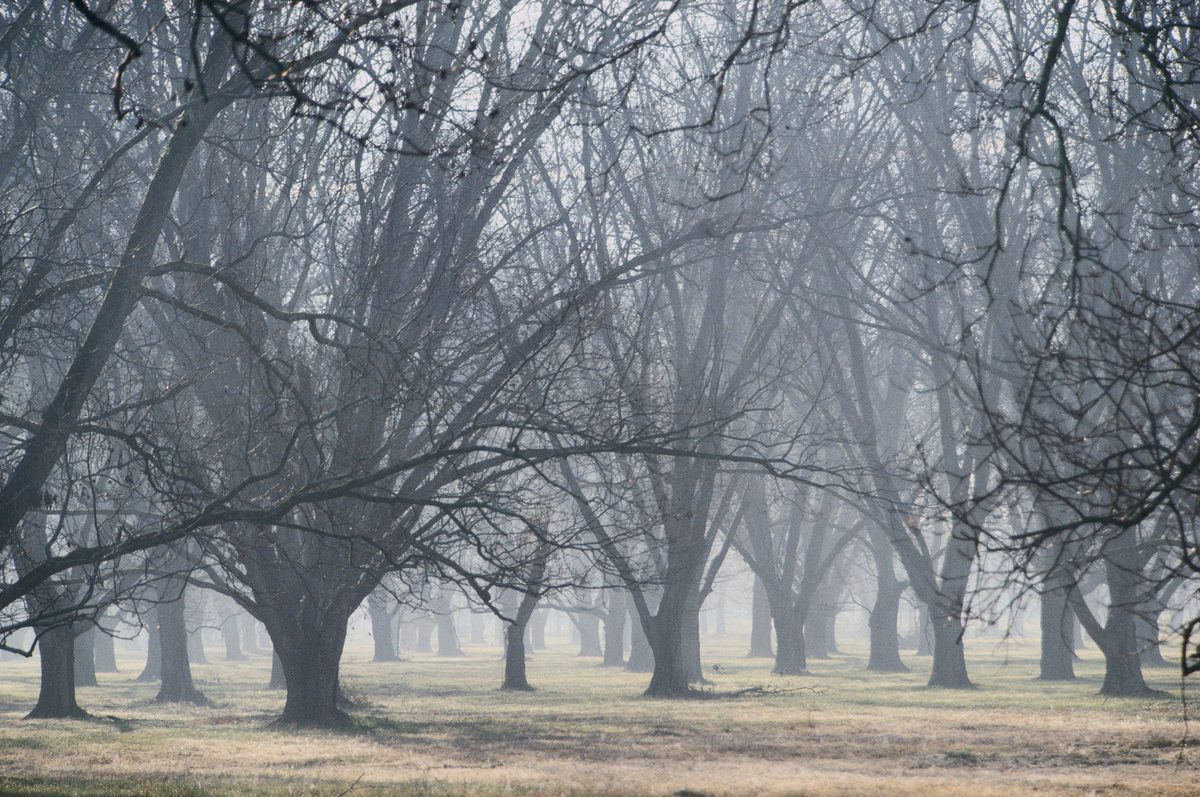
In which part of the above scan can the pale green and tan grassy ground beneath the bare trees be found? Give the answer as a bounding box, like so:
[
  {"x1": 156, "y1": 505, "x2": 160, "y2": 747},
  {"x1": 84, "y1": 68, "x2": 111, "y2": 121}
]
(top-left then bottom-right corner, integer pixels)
[{"x1": 0, "y1": 640, "x2": 1200, "y2": 797}]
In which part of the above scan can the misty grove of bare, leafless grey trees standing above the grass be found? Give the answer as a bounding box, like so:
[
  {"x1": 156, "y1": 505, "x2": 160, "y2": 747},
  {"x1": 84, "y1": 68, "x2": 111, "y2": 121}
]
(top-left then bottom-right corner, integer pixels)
[{"x1": 0, "y1": 0, "x2": 1200, "y2": 725}]
